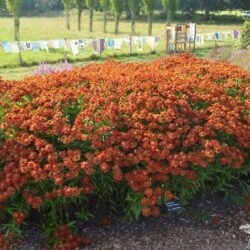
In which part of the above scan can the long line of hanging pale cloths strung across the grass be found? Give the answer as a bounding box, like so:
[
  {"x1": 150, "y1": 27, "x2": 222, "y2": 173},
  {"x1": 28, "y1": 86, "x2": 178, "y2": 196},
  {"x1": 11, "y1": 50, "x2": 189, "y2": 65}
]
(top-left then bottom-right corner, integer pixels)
[{"x1": 0, "y1": 30, "x2": 240, "y2": 55}]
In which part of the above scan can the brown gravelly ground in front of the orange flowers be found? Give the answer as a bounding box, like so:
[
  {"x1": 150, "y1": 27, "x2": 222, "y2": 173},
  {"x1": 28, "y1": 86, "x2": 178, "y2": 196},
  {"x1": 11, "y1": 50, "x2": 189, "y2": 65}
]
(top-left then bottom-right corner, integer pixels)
[{"x1": 13, "y1": 195, "x2": 250, "y2": 250}]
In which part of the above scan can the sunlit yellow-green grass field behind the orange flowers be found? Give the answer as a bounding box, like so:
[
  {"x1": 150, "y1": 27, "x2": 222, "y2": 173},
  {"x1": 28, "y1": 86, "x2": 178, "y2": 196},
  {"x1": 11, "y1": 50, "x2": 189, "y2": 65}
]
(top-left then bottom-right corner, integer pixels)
[{"x1": 0, "y1": 10, "x2": 242, "y2": 79}]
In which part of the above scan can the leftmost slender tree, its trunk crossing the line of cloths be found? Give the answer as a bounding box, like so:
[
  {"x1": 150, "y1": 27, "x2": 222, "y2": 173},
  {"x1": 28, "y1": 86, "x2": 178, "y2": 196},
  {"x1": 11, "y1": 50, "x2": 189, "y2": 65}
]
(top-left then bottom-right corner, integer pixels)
[{"x1": 6, "y1": 0, "x2": 23, "y2": 65}]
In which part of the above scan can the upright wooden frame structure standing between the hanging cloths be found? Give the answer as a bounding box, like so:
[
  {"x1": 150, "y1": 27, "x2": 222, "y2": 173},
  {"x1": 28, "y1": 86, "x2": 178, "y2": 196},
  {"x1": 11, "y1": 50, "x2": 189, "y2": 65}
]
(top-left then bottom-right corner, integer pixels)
[{"x1": 166, "y1": 23, "x2": 196, "y2": 54}]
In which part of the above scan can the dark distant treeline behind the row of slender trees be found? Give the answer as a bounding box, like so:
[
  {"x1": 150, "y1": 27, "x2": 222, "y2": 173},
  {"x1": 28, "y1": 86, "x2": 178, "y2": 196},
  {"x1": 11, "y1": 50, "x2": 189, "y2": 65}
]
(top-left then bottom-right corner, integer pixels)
[{"x1": 0, "y1": 0, "x2": 250, "y2": 16}]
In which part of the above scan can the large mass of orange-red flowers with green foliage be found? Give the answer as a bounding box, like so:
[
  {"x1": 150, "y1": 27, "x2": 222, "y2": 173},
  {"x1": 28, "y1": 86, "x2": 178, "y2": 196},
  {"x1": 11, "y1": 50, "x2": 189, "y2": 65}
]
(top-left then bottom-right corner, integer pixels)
[{"x1": 0, "y1": 55, "x2": 250, "y2": 249}]
